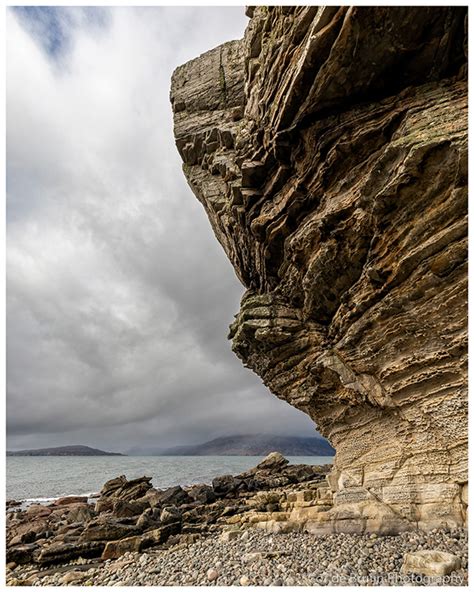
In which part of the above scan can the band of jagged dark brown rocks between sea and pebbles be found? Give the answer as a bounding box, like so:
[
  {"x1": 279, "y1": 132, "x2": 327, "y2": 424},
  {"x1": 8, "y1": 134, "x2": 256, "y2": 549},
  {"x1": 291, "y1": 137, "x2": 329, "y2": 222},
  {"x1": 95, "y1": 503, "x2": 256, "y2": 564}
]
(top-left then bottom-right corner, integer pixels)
[{"x1": 6, "y1": 453, "x2": 329, "y2": 568}]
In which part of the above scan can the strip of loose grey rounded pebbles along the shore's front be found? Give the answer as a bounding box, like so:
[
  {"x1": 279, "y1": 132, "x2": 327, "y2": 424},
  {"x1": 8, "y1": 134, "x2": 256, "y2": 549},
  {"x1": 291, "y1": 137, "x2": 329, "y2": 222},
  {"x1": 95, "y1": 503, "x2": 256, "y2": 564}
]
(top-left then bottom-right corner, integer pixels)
[{"x1": 7, "y1": 529, "x2": 468, "y2": 586}]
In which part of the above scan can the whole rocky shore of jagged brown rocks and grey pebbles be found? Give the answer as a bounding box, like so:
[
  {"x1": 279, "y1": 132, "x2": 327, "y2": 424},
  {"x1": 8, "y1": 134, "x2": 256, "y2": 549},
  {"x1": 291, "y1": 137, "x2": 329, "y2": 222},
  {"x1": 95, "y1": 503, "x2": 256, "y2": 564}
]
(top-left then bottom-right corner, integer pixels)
[{"x1": 6, "y1": 453, "x2": 467, "y2": 586}]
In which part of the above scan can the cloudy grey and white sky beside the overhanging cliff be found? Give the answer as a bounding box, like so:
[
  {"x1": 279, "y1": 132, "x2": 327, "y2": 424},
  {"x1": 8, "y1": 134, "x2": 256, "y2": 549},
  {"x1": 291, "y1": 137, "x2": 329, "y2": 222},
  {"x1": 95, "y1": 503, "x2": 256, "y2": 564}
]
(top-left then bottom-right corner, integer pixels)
[{"x1": 7, "y1": 7, "x2": 314, "y2": 451}]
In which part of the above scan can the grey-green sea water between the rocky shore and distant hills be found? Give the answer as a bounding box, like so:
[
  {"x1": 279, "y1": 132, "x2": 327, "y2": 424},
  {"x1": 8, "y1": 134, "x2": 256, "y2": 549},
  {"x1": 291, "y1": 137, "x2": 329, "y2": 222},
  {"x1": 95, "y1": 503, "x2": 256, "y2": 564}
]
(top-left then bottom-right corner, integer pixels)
[{"x1": 6, "y1": 456, "x2": 333, "y2": 501}]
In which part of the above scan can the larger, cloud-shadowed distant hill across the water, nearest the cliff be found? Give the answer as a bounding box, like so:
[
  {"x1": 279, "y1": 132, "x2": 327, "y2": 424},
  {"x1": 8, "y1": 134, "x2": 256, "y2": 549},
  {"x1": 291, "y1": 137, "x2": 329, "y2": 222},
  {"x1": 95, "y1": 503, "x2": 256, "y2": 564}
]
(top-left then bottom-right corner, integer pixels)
[{"x1": 129, "y1": 434, "x2": 335, "y2": 456}]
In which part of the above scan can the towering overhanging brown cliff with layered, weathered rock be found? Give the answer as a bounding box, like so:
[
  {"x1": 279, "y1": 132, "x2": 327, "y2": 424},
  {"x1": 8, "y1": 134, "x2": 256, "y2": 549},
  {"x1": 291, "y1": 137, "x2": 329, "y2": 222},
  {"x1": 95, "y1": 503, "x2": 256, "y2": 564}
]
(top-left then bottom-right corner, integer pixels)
[{"x1": 171, "y1": 6, "x2": 467, "y2": 532}]
